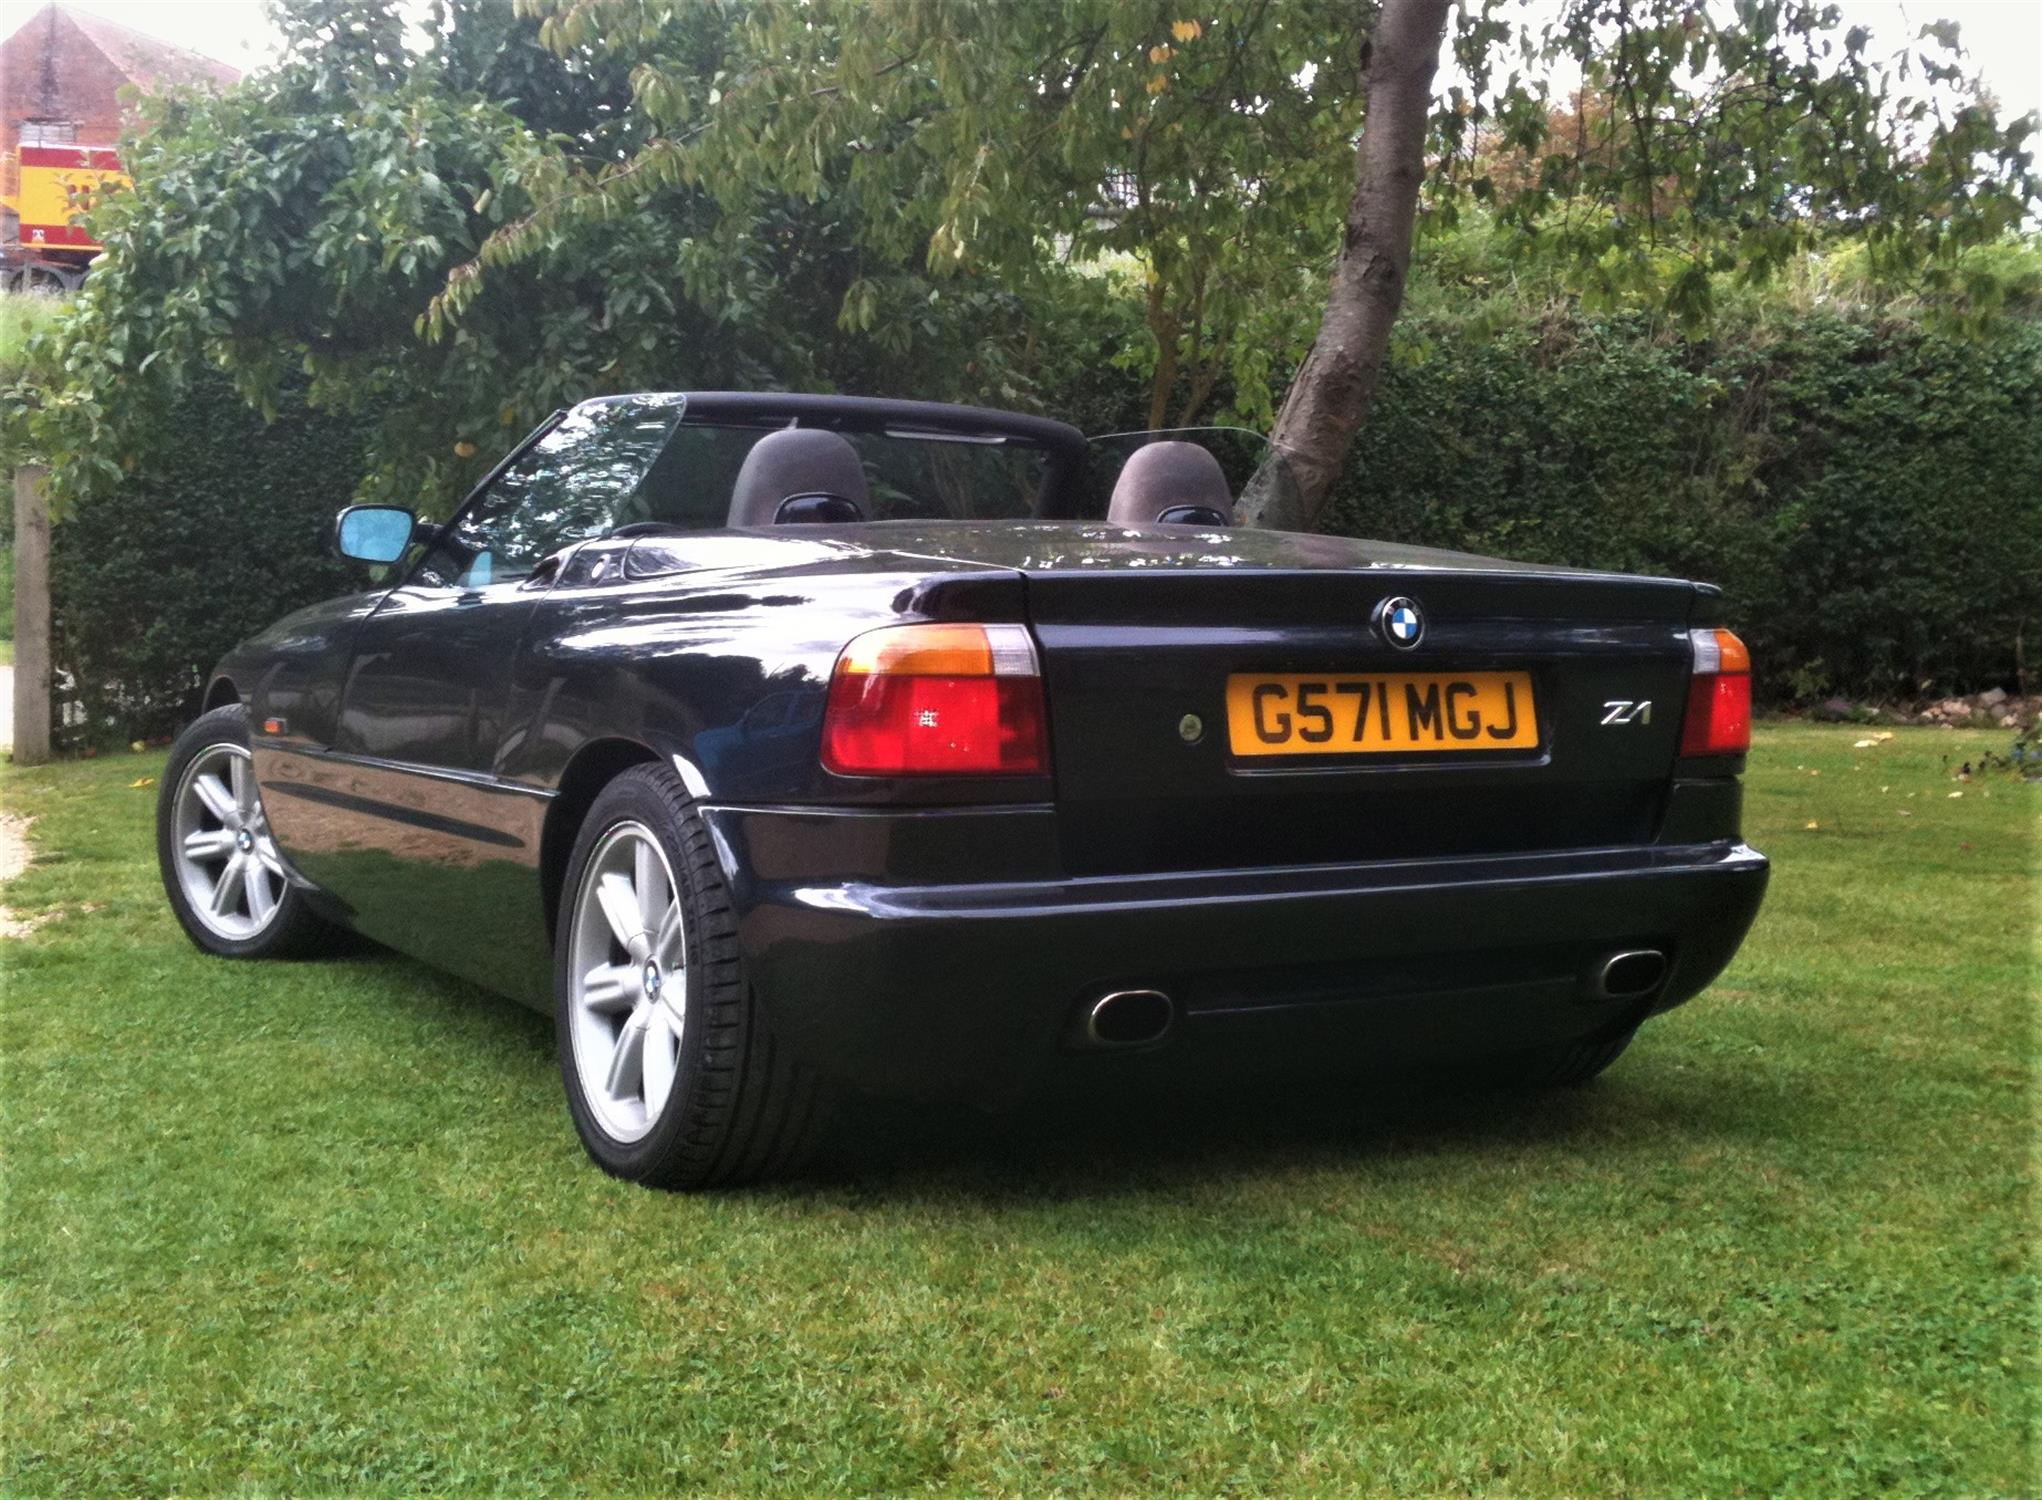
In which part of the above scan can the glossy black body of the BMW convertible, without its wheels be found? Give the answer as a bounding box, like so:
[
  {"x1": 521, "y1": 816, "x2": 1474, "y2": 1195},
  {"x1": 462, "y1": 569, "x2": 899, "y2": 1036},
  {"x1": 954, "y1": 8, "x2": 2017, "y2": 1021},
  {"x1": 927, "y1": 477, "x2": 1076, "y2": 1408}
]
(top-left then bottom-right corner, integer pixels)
[{"x1": 167, "y1": 396, "x2": 1766, "y2": 1183}]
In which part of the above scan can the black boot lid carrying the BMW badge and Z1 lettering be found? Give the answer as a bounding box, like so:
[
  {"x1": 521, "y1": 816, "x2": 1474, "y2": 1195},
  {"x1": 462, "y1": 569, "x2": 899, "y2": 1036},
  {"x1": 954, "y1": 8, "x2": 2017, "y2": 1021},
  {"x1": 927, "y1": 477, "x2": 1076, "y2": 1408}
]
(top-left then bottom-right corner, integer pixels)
[{"x1": 1023, "y1": 551, "x2": 1699, "y2": 876}]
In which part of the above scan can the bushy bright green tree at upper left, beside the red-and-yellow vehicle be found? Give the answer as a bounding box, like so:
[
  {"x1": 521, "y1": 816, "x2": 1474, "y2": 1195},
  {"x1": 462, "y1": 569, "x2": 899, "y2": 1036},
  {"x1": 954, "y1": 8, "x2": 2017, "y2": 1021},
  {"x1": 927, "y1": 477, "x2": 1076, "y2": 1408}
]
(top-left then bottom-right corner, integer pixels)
[{"x1": 14, "y1": 0, "x2": 604, "y2": 510}]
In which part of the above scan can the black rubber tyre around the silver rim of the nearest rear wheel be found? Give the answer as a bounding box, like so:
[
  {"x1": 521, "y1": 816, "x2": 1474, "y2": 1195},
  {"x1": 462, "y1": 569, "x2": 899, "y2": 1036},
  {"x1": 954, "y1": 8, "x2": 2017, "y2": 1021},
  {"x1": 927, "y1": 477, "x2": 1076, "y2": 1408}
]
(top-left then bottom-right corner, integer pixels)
[{"x1": 553, "y1": 763, "x2": 833, "y2": 1188}]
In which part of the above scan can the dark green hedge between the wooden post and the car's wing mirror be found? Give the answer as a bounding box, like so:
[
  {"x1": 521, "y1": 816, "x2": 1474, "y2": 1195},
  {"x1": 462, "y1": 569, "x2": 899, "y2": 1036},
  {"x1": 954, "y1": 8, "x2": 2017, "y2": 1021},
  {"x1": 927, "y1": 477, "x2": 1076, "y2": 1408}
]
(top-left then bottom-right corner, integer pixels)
[{"x1": 49, "y1": 380, "x2": 366, "y2": 747}]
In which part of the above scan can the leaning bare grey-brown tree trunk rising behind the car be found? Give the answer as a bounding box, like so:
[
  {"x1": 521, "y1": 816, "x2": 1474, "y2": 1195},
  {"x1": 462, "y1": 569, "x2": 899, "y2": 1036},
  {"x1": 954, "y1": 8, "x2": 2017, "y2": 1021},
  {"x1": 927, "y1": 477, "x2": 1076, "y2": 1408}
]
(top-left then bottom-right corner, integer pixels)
[{"x1": 1239, "y1": 0, "x2": 1450, "y2": 531}]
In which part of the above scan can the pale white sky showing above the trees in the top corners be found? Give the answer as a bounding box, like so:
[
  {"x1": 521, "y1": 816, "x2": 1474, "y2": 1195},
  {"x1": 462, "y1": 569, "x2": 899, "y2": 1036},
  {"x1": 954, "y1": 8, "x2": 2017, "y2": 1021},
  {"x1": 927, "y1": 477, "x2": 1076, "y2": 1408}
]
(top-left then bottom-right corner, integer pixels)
[{"x1": 39, "y1": 0, "x2": 2042, "y2": 114}]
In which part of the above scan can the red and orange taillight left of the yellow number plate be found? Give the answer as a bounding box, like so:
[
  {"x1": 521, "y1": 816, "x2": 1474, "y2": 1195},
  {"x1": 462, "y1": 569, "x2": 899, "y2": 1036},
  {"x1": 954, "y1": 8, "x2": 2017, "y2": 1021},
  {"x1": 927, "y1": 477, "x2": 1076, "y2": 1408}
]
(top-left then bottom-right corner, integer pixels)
[{"x1": 823, "y1": 624, "x2": 1050, "y2": 776}]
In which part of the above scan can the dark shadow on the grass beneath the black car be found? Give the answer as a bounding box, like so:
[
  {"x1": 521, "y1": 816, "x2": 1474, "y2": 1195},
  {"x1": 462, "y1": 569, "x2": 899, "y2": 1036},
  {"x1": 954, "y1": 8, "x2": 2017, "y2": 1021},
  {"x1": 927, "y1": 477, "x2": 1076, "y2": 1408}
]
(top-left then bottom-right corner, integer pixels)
[{"x1": 330, "y1": 945, "x2": 1788, "y2": 1204}]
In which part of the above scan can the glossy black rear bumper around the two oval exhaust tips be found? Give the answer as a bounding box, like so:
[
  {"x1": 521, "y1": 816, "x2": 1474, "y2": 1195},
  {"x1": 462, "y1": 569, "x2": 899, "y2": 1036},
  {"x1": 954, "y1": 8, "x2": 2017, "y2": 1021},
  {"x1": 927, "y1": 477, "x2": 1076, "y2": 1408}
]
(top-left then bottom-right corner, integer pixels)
[{"x1": 704, "y1": 808, "x2": 1766, "y2": 1100}]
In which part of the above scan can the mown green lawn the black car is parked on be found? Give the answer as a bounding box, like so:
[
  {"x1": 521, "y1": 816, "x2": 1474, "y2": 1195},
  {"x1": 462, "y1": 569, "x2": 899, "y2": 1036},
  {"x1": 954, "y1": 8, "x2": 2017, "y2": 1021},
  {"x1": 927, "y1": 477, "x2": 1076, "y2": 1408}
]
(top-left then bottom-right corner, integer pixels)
[{"x1": 0, "y1": 729, "x2": 2042, "y2": 1496}]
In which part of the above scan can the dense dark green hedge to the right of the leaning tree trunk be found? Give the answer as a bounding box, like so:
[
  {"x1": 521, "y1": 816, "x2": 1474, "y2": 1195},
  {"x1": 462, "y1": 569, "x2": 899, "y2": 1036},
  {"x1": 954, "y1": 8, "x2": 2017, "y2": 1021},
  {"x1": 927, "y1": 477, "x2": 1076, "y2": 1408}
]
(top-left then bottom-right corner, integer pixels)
[{"x1": 1329, "y1": 312, "x2": 2042, "y2": 702}]
